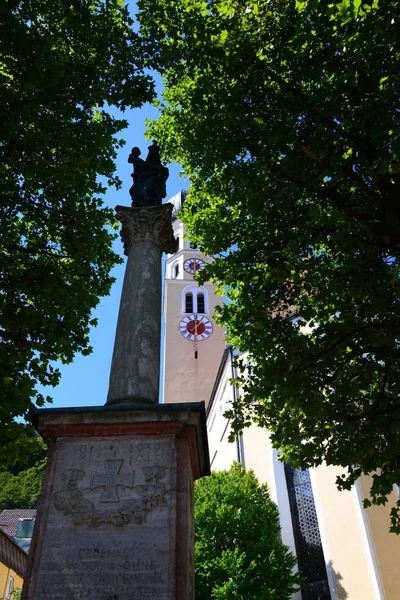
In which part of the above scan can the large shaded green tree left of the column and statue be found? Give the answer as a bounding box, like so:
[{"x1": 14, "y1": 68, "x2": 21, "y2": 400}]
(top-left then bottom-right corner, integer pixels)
[{"x1": 0, "y1": 0, "x2": 153, "y2": 459}]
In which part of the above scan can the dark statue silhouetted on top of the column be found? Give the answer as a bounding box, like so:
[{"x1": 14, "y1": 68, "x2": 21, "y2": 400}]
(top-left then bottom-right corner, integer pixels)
[{"x1": 128, "y1": 142, "x2": 169, "y2": 208}]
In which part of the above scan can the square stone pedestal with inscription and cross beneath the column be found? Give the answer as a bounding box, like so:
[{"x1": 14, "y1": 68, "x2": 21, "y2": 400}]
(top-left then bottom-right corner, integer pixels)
[{"x1": 22, "y1": 403, "x2": 209, "y2": 600}]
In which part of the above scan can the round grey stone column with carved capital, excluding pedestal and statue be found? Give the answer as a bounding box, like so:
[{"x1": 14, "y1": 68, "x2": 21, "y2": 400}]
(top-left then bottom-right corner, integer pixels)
[{"x1": 107, "y1": 204, "x2": 176, "y2": 404}]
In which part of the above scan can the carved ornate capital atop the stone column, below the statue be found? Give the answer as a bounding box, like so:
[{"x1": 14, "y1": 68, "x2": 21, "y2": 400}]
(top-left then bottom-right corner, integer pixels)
[{"x1": 115, "y1": 202, "x2": 177, "y2": 256}]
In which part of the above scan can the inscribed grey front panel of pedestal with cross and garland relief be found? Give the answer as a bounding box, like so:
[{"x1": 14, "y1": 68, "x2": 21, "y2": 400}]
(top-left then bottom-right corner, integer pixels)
[{"x1": 35, "y1": 436, "x2": 176, "y2": 600}]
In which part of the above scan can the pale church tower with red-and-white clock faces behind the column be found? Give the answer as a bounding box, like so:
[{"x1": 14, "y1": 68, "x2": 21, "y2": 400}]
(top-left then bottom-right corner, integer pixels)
[{"x1": 164, "y1": 191, "x2": 225, "y2": 404}]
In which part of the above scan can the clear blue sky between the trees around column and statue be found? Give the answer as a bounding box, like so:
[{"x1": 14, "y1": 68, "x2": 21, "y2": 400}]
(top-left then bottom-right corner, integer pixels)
[{"x1": 44, "y1": 105, "x2": 188, "y2": 408}]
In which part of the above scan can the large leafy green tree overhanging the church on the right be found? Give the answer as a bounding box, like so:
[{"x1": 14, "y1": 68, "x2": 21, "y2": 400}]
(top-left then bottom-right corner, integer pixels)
[{"x1": 140, "y1": 0, "x2": 400, "y2": 531}]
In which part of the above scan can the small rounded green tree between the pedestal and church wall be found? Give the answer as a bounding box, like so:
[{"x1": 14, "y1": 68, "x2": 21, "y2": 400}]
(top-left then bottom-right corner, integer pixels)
[{"x1": 194, "y1": 464, "x2": 301, "y2": 600}]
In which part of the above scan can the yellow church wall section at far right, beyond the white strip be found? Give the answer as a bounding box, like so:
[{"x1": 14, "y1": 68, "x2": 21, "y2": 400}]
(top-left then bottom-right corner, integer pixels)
[{"x1": 360, "y1": 475, "x2": 400, "y2": 600}]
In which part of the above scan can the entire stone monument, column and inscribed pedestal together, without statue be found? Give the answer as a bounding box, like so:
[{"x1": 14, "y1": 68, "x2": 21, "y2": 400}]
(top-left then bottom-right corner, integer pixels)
[{"x1": 22, "y1": 185, "x2": 210, "y2": 600}]
